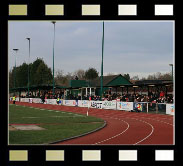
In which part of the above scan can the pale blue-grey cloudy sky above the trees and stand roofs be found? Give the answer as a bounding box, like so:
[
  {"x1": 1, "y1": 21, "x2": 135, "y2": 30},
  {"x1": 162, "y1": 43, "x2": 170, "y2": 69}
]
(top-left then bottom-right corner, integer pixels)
[{"x1": 8, "y1": 21, "x2": 174, "y2": 78}]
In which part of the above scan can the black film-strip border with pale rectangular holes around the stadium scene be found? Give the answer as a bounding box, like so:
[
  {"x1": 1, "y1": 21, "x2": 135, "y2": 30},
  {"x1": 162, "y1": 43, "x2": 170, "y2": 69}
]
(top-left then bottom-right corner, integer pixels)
[{"x1": 0, "y1": 0, "x2": 180, "y2": 166}]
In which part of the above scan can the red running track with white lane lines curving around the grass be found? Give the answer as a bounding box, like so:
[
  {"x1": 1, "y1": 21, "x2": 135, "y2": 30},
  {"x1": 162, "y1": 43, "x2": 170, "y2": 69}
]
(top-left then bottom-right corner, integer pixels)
[{"x1": 10, "y1": 102, "x2": 174, "y2": 145}]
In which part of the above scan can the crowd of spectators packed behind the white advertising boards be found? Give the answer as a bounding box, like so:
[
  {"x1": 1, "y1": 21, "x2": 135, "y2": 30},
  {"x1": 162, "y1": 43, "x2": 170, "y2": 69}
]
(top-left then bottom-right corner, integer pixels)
[{"x1": 17, "y1": 91, "x2": 173, "y2": 103}]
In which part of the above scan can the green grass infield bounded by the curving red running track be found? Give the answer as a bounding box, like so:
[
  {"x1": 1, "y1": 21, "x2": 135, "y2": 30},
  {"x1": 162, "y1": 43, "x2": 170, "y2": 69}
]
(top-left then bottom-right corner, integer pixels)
[{"x1": 9, "y1": 105, "x2": 104, "y2": 145}]
